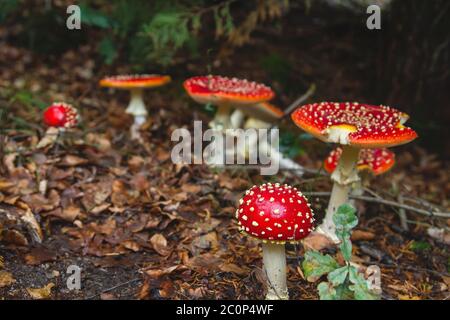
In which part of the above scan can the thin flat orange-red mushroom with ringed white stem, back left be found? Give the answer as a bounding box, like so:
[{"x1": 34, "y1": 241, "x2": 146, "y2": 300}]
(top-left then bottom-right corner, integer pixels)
[{"x1": 100, "y1": 74, "x2": 171, "y2": 139}]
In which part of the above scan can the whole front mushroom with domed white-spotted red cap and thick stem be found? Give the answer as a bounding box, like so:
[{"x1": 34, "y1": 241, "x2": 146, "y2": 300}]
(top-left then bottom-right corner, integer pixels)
[{"x1": 236, "y1": 183, "x2": 314, "y2": 300}]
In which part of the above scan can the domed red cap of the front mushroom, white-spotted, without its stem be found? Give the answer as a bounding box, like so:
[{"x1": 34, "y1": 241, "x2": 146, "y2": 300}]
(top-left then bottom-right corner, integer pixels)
[{"x1": 236, "y1": 183, "x2": 314, "y2": 243}]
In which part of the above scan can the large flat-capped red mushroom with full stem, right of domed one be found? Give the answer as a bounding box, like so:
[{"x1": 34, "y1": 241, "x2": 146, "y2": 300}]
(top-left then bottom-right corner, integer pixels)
[{"x1": 291, "y1": 102, "x2": 417, "y2": 242}]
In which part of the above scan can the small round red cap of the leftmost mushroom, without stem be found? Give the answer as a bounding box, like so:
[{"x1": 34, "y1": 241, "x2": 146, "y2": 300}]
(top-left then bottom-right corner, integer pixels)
[{"x1": 44, "y1": 102, "x2": 78, "y2": 128}]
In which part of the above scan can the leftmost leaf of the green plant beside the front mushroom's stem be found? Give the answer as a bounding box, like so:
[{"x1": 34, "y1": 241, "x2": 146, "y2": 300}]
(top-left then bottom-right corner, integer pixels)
[{"x1": 302, "y1": 251, "x2": 340, "y2": 282}]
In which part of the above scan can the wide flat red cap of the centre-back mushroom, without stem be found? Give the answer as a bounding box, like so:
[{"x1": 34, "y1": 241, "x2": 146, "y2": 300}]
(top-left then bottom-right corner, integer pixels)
[{"x1": 183, "y1": 75, "x2": 275, "y2": 104}]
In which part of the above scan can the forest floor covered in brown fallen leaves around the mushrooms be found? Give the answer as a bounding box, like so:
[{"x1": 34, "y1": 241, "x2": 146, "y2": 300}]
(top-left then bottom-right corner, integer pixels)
[{"x1": 0, "y1": 25, "x2": 450, "y2": 299}]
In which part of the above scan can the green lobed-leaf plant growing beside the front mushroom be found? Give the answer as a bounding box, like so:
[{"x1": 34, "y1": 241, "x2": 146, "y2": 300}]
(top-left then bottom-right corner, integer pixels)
[{"x1": 302, "y1": 204, "x2": 380, "y2": 300}]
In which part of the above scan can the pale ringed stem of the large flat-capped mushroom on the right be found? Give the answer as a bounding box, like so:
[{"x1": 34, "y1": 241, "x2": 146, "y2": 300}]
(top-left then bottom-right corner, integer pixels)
[{"x1": 316, "y1": 146, "x2": 359, "y2": 243}]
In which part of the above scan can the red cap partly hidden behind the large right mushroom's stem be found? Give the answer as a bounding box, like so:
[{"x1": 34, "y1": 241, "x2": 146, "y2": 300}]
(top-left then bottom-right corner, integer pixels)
[{"x1": 324, "y1": 148, "x2": 395, "y2": 175}]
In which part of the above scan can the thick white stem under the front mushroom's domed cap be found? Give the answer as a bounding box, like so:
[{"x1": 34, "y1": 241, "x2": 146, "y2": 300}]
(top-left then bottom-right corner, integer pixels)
[{"x1": 262, "y1": 242, "x2": 289, "y2": 300}]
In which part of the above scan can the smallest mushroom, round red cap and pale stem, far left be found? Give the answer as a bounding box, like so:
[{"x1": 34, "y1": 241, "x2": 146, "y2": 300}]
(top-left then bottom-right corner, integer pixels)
[{"x1": 36, "y1": 102, "x2": 79, "y2": 149}]
